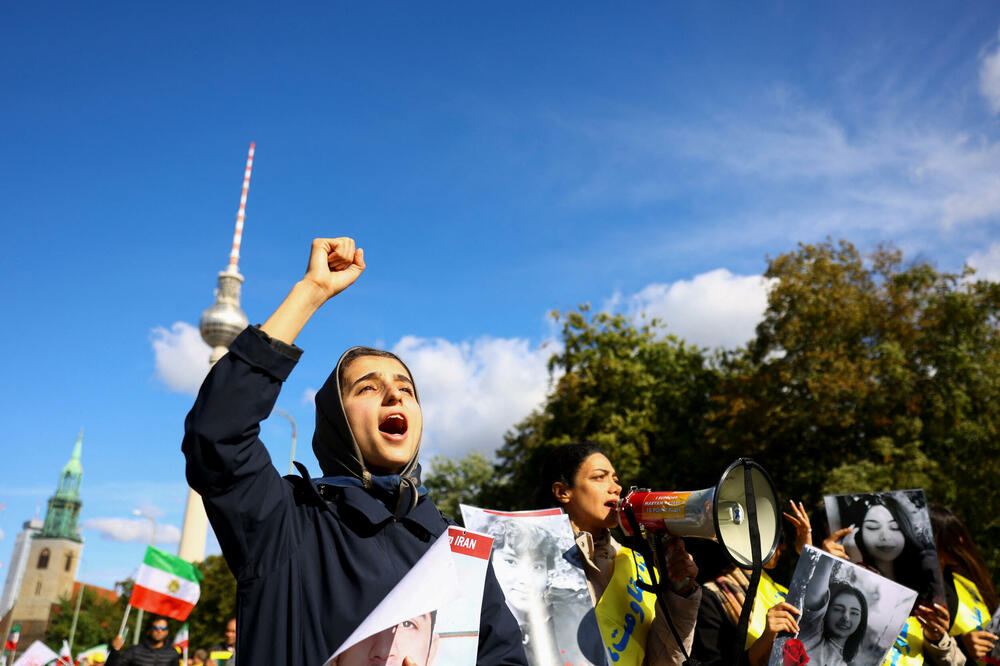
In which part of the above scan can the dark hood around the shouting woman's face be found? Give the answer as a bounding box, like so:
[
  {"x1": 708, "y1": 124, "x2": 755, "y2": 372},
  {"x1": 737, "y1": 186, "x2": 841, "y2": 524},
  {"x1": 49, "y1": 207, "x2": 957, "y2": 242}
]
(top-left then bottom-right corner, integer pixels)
[{"x1": 313, "y1": 347, "x2": 423, "y2": 482}]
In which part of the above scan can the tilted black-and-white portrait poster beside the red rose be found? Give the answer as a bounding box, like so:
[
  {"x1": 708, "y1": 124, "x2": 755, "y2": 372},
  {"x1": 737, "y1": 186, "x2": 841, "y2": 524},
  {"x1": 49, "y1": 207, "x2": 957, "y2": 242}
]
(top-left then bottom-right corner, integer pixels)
[{"x1": 768, "y1": 546, "x2": 917, "y2": 666}]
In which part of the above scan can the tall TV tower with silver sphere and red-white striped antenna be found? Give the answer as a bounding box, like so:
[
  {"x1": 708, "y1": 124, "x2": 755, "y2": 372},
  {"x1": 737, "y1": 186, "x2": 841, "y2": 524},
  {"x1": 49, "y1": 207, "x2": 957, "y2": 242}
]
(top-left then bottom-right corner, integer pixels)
[{"x1": 177, "y1": 143, "x2": 254, "y2": 562}]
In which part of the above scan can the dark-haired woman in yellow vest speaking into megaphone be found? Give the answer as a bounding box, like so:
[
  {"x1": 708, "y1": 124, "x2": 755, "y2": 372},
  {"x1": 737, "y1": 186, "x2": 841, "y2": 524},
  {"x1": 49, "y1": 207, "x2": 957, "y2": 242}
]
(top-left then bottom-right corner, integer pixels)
[{"x1": 536, "y1": 443, "x2": 701, "y2": 666}]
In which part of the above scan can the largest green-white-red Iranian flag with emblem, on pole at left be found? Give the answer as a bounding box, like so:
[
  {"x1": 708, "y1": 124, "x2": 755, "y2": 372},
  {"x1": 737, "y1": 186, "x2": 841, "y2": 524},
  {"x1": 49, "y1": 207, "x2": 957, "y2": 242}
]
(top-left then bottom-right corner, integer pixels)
[{"x1": 129, "y1": 546, "x2": 202, "y2": 621}]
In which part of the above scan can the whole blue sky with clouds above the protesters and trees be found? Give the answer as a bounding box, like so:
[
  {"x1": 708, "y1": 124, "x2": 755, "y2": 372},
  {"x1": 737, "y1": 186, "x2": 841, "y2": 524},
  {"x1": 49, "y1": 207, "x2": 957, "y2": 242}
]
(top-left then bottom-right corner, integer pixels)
[{"x1": 0, "y1": 2, "x2": 1000, "y2": 585}]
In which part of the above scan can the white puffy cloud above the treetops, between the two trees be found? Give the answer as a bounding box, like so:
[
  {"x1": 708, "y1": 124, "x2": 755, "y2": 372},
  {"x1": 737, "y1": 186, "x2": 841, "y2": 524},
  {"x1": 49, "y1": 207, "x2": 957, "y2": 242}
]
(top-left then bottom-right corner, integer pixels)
[{"x1": 606, "y1": 268, "x2": 768, "y2": 348}]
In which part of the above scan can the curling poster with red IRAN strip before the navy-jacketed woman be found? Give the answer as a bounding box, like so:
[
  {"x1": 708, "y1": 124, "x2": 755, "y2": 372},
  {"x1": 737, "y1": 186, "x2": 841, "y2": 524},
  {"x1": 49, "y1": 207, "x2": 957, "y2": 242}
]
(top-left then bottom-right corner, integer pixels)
[{"x1": 324, "y1": 527, "x2": 493, "y2": 666}]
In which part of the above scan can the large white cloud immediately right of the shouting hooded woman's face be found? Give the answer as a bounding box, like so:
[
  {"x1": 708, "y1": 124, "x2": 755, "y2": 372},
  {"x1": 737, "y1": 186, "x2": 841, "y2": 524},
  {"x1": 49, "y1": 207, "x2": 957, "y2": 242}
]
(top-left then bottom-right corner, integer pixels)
[{"x1": 392, "y1": 336, "x2": 552, "y2": 460}]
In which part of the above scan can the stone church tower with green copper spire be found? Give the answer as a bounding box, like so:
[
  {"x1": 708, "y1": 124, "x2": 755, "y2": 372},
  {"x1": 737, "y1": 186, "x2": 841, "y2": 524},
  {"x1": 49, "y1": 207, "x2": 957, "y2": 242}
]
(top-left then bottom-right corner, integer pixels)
[{"x1": 0, "y1": 431, "x2": 83, "y2": 645}]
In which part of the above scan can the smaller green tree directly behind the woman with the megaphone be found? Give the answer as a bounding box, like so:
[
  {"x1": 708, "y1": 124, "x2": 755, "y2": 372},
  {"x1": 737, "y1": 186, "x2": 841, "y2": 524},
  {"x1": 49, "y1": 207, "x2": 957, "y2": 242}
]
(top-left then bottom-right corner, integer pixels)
[{"x1": 488, "y1": 306, "x2": 728, "y2": 508}]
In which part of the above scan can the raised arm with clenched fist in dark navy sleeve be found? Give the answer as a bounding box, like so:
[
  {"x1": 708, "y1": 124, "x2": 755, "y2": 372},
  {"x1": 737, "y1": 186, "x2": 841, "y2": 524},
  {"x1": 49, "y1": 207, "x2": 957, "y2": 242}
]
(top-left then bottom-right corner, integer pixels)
[{"x1": 181, "y1": 238, "x2": 364, "y2": 580}]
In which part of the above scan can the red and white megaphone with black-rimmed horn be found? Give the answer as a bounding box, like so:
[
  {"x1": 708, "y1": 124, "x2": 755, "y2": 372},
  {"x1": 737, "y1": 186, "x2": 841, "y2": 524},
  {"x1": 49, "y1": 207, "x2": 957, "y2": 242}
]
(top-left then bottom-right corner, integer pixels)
[{"x1": 618, "y1": 458, "x2": 781, "y2": 569}]
